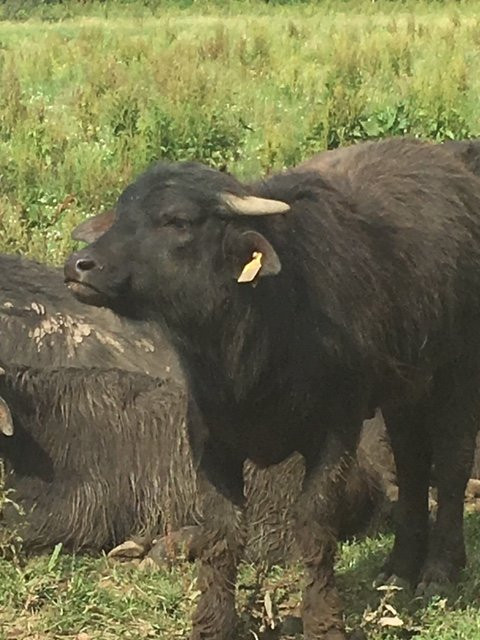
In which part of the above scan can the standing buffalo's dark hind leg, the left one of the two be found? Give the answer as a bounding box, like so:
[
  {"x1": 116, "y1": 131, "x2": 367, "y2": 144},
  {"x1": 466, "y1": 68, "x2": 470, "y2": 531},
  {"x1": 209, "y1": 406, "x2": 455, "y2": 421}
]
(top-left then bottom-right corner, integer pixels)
[{"x1": 376, "y1": 407, "x2": 432, "y2": 585}]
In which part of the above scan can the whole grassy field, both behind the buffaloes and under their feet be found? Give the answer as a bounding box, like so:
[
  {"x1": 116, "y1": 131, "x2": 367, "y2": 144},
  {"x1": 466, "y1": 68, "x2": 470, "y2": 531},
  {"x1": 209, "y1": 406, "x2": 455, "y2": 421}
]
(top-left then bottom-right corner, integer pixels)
[{"x1": 0, "y1": 0, "x2": 480, "y2": 640}]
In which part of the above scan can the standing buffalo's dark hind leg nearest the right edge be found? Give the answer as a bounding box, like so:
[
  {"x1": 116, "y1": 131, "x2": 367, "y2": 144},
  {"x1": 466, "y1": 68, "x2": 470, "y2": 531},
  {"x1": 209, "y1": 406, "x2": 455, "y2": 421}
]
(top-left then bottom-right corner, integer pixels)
[{"x1": 417, "y1": 372, "x2": 480, "y2": 597}]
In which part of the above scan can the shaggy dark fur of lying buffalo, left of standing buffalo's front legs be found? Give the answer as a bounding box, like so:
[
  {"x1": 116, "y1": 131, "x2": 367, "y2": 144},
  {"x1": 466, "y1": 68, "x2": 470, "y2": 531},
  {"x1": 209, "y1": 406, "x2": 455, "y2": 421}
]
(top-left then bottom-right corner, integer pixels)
[{"x1": 0, "y1": 367, "x2": 191, "y2": 550}]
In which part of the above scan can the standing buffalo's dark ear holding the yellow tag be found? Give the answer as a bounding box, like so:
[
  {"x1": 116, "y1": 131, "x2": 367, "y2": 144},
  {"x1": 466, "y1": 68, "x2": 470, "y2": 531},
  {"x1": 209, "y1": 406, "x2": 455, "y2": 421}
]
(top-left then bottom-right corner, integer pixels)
[{"x1": 229, "y1": 231, "x2": 282, "y2": 283}]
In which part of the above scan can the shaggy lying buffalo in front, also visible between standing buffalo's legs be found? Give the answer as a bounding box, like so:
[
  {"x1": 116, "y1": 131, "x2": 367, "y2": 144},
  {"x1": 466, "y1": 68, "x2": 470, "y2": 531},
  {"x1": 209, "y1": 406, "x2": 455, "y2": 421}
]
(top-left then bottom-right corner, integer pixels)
[{"x1": 0, "y1": 366, "x2": 391, "y2": 563}]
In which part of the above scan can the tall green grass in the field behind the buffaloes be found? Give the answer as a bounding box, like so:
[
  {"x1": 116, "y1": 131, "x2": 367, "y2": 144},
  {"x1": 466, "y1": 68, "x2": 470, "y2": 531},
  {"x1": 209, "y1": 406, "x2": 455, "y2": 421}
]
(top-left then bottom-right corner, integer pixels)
[{"x1": 0, "y1": 0, "x2": 480, "y2": 262}]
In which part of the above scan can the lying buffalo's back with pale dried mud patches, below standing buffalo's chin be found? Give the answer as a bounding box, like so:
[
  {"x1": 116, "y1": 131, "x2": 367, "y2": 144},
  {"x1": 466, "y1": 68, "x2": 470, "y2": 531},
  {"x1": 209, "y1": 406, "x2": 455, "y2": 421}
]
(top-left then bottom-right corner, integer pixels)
[{"x1": 0, "y1": 254, "x2": 180, "y2": 378}]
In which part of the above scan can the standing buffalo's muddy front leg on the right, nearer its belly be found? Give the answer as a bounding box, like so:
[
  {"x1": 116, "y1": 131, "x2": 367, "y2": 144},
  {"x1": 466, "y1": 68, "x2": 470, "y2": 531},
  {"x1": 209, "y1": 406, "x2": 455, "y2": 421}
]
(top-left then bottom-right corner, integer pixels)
[{"x1": 295, "y1": 432, "x2": 354, "y2": 640}]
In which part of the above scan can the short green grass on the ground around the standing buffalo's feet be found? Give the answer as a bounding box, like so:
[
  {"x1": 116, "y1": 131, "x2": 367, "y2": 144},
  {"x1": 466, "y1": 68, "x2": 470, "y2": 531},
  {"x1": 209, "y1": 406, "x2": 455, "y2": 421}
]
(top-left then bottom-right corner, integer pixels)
[{"x1": 0, "y1": 515, "x2": 480, "y2": 640}]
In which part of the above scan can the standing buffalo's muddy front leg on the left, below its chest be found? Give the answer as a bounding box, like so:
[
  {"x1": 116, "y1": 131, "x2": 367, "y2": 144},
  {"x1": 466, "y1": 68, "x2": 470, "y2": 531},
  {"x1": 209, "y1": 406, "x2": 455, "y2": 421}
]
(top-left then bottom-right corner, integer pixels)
[{"x1": 190, "y1": 444, "x2": 245, "y2": 640}]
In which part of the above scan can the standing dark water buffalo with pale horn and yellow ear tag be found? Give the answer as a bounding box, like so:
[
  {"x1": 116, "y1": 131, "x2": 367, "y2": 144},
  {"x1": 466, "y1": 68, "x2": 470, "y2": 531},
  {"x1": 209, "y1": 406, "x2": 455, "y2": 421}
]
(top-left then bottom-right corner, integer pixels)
[{"x1": 65, "y1": 139, "x2": 480, "y2": 640}]
